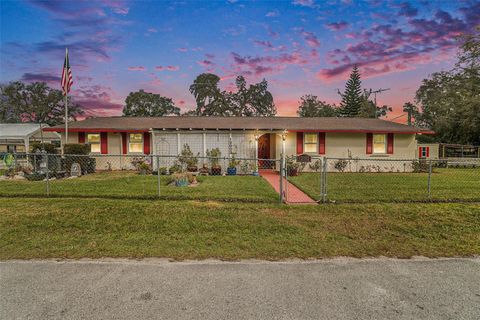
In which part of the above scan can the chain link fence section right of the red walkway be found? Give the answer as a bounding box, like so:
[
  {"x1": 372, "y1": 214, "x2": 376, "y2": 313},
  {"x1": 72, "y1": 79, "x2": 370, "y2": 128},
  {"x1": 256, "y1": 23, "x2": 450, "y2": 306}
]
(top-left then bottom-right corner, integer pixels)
[{"x1": 286, "y1": 157, "x2": 480, "y2": 203}]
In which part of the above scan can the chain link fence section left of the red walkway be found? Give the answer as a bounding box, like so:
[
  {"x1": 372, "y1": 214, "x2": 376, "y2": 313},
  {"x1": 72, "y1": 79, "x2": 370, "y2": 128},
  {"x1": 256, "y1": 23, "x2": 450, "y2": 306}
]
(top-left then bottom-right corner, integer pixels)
[{"x1": 0, "y1": 152, "x2": 280, "y2": 202}]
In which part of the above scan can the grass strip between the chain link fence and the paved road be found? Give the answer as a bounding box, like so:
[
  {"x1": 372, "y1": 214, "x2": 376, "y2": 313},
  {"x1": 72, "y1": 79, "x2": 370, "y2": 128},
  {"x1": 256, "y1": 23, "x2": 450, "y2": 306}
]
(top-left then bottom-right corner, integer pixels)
[{"x1": 0, "y1": 198, "x2": 480, "y2": 260}]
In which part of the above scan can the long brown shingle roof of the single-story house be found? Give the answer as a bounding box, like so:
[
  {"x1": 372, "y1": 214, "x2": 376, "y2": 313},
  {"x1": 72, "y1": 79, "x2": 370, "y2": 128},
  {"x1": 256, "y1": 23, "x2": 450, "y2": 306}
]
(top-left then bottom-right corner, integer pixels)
[{"x1": 45, "y1": 116, "x2": 433, "y2": 133}]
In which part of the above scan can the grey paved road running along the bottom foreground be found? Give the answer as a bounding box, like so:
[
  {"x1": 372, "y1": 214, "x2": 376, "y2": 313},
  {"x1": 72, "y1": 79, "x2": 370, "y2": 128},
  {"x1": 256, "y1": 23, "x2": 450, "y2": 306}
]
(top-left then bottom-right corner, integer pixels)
[{"x1": 0, "y1": 258, "x2": 480, "y2": 319}]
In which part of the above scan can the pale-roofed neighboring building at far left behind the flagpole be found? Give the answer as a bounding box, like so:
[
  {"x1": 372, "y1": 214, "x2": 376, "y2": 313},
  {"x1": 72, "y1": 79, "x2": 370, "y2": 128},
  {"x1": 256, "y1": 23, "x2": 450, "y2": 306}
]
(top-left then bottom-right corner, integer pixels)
[{"x1": 0, "y1": 123, "x2": 60, "y2": 153}]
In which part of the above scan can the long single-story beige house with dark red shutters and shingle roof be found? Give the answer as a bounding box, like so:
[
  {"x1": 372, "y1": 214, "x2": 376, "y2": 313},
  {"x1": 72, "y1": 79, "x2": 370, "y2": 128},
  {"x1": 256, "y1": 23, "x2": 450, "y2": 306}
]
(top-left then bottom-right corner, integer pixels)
[{"x1": 44, "y1": 116, "x2": 433, "y2": 169}]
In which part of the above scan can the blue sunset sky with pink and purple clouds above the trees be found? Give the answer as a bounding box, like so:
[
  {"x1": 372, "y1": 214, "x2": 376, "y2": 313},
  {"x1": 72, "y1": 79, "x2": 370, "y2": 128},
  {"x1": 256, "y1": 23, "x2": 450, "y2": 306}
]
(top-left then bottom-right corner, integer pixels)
[{"x1": 0, "y1": 0, "x2": 480, "y2": 121}]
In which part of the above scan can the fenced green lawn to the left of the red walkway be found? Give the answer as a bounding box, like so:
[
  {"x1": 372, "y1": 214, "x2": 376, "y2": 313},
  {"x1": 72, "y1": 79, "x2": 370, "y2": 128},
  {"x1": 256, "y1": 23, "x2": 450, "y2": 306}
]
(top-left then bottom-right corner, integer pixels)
[{"x1": 0, "y1": 172, "x2": 279, "y2": 202}]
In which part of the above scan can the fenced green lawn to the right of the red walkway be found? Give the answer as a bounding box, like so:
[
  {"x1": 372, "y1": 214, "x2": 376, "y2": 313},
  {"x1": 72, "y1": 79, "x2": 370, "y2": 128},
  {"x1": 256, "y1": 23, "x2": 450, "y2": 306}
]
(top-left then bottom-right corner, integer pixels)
[{"x1": 290, "y1": 168, "x2": 480, "y2": 202}]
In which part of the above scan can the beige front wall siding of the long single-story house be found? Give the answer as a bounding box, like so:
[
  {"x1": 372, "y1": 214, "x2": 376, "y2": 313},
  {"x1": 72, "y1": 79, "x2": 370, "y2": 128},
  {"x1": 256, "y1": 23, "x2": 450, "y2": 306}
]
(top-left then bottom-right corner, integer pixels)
[{"x1": 55, "y1": 130, "x2": 416, "y2": 171}]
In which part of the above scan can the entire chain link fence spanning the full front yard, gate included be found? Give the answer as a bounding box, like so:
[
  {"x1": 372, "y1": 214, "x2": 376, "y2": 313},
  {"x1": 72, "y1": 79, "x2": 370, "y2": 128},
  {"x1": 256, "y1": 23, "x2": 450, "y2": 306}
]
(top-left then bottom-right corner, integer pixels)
[{"x1": 0, "y1": 152, "x2": 480, "y2": 203}]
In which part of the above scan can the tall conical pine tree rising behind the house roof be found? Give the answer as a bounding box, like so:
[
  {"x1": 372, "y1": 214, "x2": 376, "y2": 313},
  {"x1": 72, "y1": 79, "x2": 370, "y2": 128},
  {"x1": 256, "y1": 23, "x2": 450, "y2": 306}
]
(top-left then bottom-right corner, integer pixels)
[{"x1": 339, "y1": 66, "x2": 363, "y2": 117}]
